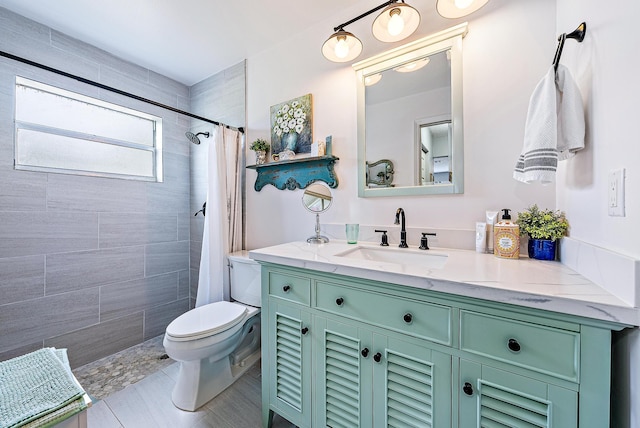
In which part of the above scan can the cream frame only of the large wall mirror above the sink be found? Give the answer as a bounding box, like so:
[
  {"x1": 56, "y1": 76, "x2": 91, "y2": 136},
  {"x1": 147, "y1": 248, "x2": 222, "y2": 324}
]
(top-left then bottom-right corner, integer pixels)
[{"x1": 353, "y1": 22, "x2": 468, "y2": 198}]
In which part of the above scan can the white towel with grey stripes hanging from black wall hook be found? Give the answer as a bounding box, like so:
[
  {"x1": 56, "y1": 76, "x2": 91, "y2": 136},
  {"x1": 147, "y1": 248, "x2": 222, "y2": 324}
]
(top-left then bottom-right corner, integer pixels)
[{"x1": 513, "y1": 64, "x2": 585, "y2": 184}]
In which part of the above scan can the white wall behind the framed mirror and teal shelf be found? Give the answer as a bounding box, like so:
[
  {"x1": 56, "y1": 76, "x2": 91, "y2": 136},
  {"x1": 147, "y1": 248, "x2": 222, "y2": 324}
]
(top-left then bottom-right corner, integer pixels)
[{"x1": 247, "y1": 0, "x2": 556, "y2": 248}]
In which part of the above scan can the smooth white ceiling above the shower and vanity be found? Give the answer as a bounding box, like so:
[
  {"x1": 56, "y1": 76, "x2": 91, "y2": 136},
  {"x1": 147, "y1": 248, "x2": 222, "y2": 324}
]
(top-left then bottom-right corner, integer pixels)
[{"x1": 0, "y1": 0, "x2": 500, "y2": 86}]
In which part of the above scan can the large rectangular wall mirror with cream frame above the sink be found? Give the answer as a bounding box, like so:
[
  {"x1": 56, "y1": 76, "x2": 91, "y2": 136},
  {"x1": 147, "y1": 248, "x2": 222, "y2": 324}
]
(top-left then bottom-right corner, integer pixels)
[{"x1": 353, "y1": 23, "x2": 467, "y2": 197}]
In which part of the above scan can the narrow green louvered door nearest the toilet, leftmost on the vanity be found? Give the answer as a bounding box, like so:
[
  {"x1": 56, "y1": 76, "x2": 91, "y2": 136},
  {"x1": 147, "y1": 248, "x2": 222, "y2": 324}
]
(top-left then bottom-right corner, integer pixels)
[{"x1": 262, "y1": 299, "x2": 313, "y2": 427}]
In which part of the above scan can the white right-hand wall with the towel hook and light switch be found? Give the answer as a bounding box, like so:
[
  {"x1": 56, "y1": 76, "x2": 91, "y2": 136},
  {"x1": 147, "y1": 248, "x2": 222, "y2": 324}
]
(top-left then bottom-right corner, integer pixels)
[{"x1": 556, "y1": 0, "x2": 640, "y2": 428}]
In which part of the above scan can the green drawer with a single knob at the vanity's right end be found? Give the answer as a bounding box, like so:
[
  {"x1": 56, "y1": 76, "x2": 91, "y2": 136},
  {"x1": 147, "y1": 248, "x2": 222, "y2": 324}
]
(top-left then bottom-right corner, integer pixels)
[{"x1": 460, "y1": 310, "x2": 580, "y2": 382}]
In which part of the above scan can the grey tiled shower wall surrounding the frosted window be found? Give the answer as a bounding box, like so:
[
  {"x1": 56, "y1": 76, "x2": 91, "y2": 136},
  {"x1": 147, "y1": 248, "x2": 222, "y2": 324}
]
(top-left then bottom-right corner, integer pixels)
[{"x1": 0, "y1": 8, "x2": 244, "y2": 367}]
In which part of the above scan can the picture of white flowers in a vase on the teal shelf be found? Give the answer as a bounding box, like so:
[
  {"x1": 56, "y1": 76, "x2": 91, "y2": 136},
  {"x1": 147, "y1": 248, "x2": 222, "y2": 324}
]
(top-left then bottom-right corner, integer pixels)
[{"x1": 271, "y1": 94, "x2": 313, "y2": 154}]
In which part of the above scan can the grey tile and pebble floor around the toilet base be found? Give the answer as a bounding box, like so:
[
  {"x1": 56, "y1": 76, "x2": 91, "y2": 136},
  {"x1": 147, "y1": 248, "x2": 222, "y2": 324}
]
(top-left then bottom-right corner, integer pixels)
[{"x1": 74, "y1": 338, "x2": 294, "y2": 428}]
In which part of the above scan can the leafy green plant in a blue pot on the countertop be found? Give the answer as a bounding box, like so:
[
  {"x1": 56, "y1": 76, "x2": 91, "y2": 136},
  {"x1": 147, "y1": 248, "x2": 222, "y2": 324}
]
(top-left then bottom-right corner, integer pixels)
[{"x1": 516, "y1": 204, "x2": 569, "y2": 260}]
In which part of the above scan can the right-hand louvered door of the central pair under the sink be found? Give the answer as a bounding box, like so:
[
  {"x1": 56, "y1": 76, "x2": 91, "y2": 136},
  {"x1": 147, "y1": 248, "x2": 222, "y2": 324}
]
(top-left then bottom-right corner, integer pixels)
[{"x1": 372, "y1": 334, "x2": 452, "y2": 428}]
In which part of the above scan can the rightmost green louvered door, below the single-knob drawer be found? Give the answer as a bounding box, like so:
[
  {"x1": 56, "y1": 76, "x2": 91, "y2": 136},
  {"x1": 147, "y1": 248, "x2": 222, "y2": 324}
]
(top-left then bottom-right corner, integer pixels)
[{"x1": 458, "y1": 360, "x2": 578, "y2": 428}]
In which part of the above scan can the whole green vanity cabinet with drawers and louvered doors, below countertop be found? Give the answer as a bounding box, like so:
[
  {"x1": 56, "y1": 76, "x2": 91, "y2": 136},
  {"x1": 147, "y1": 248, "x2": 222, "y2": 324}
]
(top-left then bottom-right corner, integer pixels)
[{"x1": 262, "y1": 263, "x2": 625, "y2": 428}]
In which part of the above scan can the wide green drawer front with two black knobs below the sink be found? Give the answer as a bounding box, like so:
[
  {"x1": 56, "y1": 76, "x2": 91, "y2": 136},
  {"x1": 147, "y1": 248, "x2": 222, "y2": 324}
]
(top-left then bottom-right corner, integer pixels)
[{"x1": 316, "y1": 282, "x2": 452, "y2": 345}]
